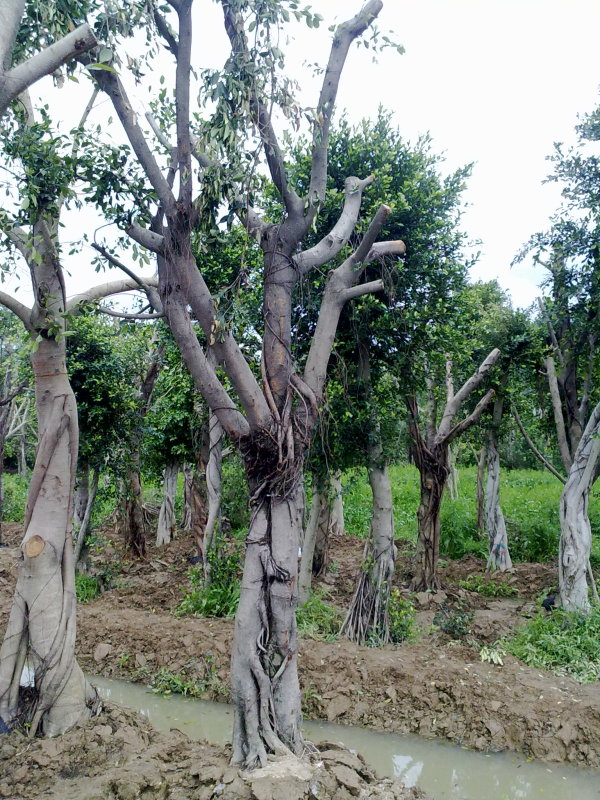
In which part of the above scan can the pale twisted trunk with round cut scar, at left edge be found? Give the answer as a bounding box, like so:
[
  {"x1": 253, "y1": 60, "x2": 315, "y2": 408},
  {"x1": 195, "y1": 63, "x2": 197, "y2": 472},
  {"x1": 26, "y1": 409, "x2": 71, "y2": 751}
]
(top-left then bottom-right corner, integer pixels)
[{"x1": 0, "y1": 338, "x2": 94, "y2": 736}]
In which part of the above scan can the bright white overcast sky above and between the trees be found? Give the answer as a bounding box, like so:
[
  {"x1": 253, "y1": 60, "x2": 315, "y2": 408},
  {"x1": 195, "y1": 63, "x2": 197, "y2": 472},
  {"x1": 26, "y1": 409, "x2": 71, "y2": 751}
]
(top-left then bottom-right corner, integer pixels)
[{"x1": 8, "y1": 0, "x2": 600, "y2": 307}]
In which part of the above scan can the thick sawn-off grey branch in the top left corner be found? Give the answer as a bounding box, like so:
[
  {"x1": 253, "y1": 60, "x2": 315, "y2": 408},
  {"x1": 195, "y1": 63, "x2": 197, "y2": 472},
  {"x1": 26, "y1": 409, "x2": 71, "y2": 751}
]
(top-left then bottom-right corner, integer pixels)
[{"x1": 0, "y1": 22, "x2": 98, "y2": 116}]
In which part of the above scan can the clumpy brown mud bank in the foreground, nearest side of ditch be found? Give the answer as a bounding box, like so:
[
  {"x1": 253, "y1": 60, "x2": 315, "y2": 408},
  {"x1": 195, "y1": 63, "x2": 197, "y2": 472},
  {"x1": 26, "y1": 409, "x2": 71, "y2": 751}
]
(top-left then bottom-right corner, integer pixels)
[{"x1": 0, "y1": 706, "x2": 427, "y2": 800}]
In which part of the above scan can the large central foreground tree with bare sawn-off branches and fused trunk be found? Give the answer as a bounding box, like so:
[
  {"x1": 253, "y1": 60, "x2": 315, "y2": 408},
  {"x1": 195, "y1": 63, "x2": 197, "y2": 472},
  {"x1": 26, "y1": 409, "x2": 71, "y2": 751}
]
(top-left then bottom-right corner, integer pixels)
[{"x1": 89, "y1": 0, "x2": 404, "y2": 767}]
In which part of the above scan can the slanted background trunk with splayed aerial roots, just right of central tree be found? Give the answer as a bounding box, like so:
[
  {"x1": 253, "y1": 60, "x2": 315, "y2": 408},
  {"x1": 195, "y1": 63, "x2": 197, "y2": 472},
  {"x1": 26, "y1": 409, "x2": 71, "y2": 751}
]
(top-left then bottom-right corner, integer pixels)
[{"x1": 342, "y1": 463, "x2": 396, "y2": 644}]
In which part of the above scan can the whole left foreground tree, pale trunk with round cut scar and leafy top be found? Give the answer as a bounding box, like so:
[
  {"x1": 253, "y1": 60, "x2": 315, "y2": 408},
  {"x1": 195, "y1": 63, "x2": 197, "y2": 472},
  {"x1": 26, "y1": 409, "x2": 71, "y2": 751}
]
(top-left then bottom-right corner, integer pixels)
[{"x1": 0, "y1": 84, "x2": 157, "y2": 736}]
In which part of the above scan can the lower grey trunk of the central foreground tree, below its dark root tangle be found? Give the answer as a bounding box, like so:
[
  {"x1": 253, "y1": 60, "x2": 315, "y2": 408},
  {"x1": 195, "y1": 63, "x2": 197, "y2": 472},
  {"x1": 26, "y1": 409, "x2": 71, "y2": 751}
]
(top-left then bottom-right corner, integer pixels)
[{"x1": 231, "y1": 484, "x2": 304, "y2": 768}]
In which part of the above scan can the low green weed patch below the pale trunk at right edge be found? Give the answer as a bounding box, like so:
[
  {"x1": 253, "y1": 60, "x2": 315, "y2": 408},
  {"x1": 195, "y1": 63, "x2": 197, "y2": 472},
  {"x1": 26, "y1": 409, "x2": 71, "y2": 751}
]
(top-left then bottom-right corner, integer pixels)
[{"x1": 504, "y1": 605, "x2": 600, "y2": 683}]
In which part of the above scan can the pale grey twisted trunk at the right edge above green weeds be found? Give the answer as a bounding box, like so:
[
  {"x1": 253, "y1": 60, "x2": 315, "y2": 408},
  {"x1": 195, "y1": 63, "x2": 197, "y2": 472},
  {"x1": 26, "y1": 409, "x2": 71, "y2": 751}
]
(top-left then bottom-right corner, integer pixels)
[{"x1": 558, "y1": 404, "x2": 600, "y2": 614}]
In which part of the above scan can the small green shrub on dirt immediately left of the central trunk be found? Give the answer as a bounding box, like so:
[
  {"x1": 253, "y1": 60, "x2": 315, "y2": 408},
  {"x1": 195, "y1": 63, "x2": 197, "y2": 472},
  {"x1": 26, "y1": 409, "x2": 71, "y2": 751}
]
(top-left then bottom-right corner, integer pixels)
[{"x1": 175, "y1": 539, "x2": 242, "y2": 617}]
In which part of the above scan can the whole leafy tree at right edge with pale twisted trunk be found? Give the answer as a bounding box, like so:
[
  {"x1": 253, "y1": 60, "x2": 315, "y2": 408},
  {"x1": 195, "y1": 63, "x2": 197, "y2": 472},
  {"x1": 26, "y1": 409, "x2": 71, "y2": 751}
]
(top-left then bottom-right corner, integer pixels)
[{"x1": 518, "y1": 101, "x2": 600, "y2": 613}]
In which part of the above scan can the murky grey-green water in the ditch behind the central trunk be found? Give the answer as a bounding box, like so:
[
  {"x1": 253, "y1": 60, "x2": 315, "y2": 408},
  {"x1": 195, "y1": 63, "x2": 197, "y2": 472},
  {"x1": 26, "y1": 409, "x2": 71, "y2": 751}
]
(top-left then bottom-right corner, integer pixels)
[{"x1": 91, "y1": 678, "x2": 600, "y2": 800}]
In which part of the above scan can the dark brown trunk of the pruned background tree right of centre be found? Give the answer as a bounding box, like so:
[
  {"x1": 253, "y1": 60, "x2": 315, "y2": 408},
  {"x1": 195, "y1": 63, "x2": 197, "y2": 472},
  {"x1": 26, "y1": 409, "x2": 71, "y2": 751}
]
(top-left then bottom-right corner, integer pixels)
[{"x1": 410, "y1": 448, "x2": 448, "y2": 592}]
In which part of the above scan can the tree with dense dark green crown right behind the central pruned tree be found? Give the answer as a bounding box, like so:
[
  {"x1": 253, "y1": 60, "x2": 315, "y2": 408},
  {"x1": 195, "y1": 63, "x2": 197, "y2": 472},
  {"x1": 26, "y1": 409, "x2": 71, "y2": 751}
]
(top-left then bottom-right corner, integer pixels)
[{"x1": 290, "y1": 109, "x2": 470, "y2": 642}]
